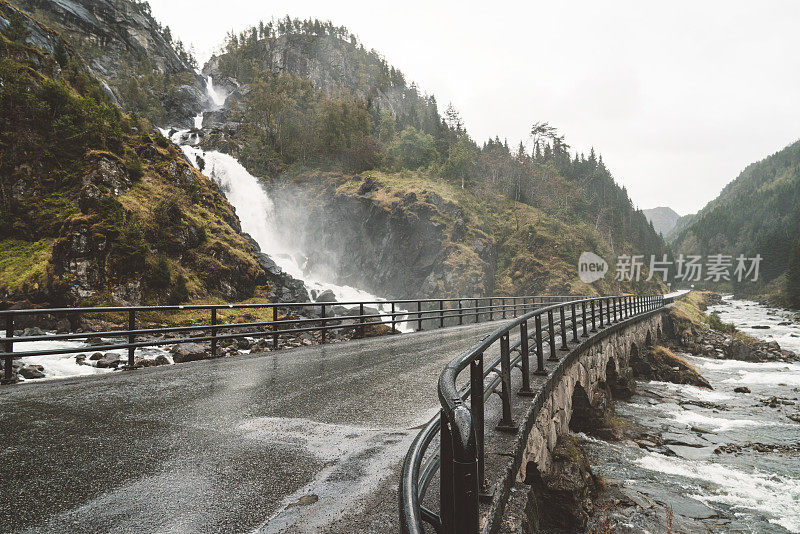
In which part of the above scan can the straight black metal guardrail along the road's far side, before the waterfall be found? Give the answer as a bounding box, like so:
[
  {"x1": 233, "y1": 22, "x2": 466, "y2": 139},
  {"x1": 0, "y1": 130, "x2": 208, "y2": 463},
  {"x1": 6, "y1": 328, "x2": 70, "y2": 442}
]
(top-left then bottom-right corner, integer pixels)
[{"x1": 0, "y1": 295, "x2": 588, "y2": 381}]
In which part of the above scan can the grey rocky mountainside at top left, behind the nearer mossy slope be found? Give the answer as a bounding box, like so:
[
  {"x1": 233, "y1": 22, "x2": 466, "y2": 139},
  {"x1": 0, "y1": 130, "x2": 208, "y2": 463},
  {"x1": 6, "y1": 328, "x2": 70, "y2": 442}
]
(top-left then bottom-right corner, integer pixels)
[{"x1": 14, "y1": 0, "x2": 207, "y2": 127}]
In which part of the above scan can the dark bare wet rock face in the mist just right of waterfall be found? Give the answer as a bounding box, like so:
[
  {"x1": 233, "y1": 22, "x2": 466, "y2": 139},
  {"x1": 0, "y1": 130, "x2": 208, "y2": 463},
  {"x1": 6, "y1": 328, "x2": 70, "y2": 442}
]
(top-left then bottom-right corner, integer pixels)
[{"x1": 271, "y1": 183, "x2": 494, "y2": 298}]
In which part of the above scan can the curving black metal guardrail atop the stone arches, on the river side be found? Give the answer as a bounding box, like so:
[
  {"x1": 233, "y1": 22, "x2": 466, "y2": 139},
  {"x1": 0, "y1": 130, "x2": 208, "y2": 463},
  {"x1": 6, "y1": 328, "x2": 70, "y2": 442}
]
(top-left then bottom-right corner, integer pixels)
[{"x1": 399, "y1": 295, "x2": 672, "y2": 534}]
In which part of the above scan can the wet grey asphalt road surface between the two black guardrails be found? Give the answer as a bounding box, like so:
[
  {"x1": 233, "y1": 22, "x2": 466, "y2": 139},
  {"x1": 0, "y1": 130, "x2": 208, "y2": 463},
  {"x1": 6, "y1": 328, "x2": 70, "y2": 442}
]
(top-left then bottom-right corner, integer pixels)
[{"x1": 0, "y1": 323, "x2": 506, "y2": 533}]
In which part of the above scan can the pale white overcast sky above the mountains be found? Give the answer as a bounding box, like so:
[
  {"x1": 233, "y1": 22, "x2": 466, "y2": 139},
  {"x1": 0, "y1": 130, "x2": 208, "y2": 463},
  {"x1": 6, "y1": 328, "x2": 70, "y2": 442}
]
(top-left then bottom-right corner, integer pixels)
[{"x1": 150, "y1": 0, "x2": 800, "y2": 215}]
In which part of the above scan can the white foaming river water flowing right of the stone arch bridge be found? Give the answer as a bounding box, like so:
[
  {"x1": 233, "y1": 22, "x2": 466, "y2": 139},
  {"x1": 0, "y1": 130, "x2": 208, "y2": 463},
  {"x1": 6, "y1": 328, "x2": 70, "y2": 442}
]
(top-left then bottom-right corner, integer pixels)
[{"x1": 586, "y1": 299, "x2": 800, "y2": 532}]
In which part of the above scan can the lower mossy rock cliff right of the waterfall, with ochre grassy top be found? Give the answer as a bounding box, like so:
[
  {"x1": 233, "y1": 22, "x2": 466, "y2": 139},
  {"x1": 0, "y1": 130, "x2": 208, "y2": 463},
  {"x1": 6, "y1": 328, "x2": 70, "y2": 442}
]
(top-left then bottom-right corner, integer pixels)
[{"x1": 269, "y1": 171, "x2": 657, "y2": 298}]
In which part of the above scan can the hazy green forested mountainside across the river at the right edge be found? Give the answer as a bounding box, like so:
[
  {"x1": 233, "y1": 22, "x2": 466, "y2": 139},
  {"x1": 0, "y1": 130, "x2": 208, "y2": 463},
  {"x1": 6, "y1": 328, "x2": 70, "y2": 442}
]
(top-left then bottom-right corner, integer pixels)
[{"x1": 674, "y1": 141, "x2": 800, "y2": 306}]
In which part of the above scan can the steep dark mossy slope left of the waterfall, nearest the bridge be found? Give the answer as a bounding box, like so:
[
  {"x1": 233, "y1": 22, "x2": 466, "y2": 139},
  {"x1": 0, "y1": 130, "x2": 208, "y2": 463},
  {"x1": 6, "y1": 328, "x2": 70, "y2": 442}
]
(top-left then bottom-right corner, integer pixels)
[{"x1": 0, "y1": 1, "x2": 278, "y2": 305}]
